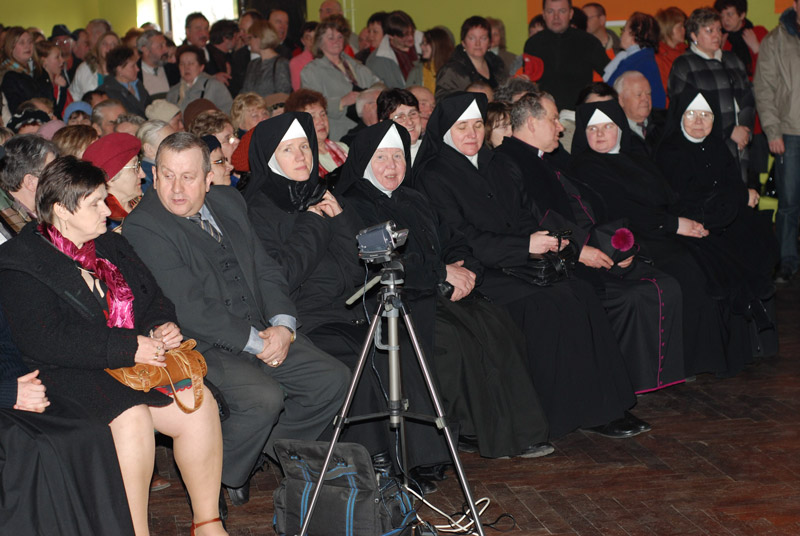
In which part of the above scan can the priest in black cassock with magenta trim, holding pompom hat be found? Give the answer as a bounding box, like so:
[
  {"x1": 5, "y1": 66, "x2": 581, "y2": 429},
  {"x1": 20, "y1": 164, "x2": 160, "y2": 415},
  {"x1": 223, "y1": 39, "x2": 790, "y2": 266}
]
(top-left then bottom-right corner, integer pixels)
[{"x1": 490, "y1": 94, "x2": 693, "y2": 394}]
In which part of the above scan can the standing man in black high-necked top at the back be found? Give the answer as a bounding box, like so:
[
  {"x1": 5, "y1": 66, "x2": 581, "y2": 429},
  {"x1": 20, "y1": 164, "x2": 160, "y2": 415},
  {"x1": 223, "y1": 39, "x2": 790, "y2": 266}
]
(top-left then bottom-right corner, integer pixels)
[{"x1": 525, "y1": 0, "x2": 609, "y2": 109}]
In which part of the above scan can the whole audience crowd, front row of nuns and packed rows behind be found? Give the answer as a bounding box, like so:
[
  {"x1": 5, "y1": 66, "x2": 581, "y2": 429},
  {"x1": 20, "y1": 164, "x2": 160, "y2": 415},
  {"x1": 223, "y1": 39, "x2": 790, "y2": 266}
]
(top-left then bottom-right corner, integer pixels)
[{"x1": 0, "y1": 0, "x2": 800, "y2": 535}]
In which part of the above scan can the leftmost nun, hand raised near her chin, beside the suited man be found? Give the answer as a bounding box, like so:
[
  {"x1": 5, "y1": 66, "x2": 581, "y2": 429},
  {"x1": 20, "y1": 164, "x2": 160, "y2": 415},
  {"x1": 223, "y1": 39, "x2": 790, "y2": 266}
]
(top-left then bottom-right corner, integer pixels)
[{"x1": 243, "y1": 112, "x2": 450, "y2": 492}]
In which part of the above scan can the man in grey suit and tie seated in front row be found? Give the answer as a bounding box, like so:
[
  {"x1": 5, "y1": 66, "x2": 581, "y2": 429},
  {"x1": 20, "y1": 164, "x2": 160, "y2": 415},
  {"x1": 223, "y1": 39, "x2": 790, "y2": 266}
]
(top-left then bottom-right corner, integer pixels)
[{"x1": 124, "y1": 132, "x2": 350, "y2": 504}]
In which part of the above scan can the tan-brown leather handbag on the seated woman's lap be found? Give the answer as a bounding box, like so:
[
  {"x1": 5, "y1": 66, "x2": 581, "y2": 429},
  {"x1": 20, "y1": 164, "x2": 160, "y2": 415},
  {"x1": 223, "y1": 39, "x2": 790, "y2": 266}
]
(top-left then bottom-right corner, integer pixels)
[{"x1": 105, "y1": 339, "x2": 208, "y2": 413}]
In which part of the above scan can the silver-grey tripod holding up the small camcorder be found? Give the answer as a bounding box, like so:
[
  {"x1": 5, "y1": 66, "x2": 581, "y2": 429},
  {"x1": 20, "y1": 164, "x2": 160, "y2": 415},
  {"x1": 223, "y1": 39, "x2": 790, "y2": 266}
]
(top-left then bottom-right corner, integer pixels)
[{"x1": 299, "y1": 259, "x2": 484, "y2": 536}]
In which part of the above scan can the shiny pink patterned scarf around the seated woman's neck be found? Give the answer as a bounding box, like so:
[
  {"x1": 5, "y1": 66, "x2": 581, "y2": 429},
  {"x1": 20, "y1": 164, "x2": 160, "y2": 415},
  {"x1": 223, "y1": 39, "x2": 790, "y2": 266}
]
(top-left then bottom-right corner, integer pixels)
[{"x1": 39, "y1": 223, "x2": 134, "y2": 329}]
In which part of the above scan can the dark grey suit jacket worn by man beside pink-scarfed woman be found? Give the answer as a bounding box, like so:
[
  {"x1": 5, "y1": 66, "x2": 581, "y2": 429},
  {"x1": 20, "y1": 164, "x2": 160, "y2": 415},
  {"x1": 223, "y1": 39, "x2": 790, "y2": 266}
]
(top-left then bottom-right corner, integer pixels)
[{"x1": 123, "y1": 186, "x2": 297, "y2": 354}]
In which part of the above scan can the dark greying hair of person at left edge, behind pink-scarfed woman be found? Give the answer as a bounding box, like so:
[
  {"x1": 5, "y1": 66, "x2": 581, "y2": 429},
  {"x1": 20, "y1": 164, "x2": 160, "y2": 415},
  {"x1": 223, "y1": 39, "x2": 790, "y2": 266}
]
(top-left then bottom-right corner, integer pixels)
[{"x1": 0, "y1": 134, "x2": 58, "y2": 193}]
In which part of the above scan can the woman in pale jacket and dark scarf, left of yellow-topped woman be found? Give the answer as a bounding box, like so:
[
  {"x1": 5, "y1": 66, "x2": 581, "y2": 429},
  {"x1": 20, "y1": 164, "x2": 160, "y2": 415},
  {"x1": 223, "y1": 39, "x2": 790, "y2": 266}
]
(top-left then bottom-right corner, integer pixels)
[{"x1": 366, "y1": 11, "x2": 422, "y2": 88}]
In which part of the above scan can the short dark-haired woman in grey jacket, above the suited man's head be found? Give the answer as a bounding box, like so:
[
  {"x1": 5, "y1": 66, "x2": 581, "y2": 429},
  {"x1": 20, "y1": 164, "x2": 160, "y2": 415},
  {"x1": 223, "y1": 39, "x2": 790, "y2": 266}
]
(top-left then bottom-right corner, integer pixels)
[{"x1": 167, "y1": 45, "x2": 233, "y2": 115}]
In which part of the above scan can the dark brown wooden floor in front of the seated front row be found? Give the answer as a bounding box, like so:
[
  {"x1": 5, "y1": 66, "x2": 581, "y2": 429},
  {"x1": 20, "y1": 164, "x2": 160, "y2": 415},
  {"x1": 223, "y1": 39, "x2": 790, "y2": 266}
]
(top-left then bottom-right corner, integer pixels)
[{"x1": 145, "y1": 288, "x2": 800, "y2": 536}]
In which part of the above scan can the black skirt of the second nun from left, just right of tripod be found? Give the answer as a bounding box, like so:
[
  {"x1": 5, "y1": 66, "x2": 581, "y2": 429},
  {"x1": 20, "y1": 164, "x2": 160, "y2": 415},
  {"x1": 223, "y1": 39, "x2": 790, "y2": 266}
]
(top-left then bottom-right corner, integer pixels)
[{"x1": 431, "y1": 297, "x2": 548, "y2": 458}]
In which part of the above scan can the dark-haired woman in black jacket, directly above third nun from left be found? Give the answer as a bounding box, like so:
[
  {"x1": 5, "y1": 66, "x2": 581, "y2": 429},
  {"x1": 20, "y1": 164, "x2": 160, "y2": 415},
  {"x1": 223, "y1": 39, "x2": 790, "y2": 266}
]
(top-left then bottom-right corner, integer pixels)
[{"x1": 435, "y1": 16, "x2": 508, "y2": 102}]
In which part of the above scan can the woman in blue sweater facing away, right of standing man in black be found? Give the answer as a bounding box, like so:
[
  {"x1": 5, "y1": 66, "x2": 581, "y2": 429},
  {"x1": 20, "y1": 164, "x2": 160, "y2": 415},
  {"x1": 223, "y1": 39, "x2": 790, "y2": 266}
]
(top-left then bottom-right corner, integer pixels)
[{"x1": 603, "y1": 11, "x2": 667, "y2": 109}]
